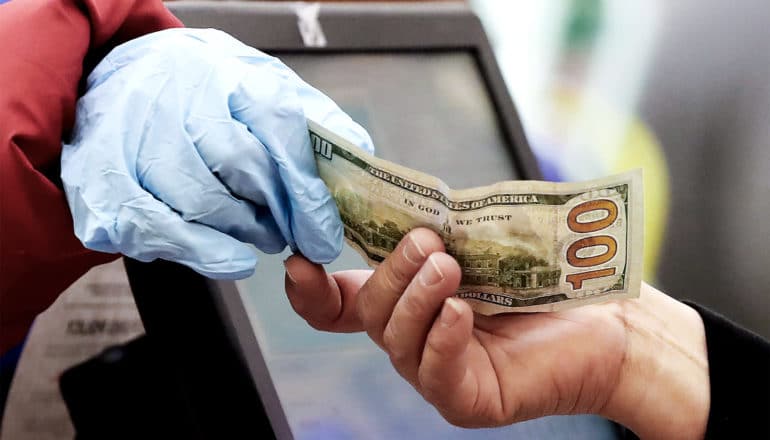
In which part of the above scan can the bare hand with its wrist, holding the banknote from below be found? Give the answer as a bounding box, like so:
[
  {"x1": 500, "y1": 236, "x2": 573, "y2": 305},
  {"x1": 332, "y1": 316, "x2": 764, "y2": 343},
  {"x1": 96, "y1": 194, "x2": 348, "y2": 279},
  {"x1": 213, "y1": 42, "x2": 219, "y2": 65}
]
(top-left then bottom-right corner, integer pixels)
[{"x1": 286, "y1": 229, "x2": 708, "y2": 438}]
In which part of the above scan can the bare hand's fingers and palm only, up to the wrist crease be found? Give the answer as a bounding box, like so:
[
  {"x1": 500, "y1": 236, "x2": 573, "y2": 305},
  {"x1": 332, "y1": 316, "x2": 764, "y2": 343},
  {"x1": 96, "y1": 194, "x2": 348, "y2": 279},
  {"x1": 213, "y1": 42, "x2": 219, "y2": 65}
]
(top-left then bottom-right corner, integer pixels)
[{"x1": 286, "y1": 229, "x2": 627, "y2": 427}]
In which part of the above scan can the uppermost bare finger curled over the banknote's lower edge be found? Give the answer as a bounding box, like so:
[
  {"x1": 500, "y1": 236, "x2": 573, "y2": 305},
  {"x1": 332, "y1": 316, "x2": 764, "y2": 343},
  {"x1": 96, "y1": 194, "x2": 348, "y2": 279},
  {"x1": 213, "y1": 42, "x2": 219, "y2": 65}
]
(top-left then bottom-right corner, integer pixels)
[{"x1": 356, "y1": 228, "x2": 444, "y2": 347}]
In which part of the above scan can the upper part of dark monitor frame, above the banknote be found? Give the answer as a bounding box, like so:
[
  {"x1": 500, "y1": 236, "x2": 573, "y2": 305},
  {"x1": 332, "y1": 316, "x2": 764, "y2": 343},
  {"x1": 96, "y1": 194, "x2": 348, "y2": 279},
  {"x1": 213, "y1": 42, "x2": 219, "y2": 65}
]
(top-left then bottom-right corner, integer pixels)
[{"x1": 169, "y1": 1, "x2": 542, "y2": 180}]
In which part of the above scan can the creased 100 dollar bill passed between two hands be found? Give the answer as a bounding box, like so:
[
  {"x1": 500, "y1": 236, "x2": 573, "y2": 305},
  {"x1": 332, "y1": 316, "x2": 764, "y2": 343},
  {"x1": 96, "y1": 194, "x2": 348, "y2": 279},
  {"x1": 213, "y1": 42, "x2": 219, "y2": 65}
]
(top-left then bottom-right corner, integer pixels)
[{"x1": 309, "y1": 121, "x2": 643, "y2": 315}]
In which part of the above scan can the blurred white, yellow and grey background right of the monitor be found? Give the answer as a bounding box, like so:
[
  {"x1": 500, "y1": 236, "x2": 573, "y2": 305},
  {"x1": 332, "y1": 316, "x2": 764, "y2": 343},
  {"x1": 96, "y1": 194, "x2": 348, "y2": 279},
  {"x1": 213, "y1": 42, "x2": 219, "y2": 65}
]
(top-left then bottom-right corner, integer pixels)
[{"x1": 470, "y1": 0, "x2": 770, "y2": 337}]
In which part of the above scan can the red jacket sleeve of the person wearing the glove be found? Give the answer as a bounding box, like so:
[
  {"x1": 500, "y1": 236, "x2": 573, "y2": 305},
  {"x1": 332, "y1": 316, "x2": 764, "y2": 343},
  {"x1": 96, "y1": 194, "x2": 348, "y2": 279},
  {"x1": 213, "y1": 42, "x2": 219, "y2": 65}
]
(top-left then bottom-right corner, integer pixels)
[{"x1": 0, "y1": 0, "x2": 182, "y2": 353}]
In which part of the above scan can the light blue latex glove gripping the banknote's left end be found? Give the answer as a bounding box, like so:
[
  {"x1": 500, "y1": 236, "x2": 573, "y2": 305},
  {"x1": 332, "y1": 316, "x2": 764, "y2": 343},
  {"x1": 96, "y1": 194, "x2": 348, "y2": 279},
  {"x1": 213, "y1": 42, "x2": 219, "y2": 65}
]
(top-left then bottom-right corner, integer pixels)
[{"x1": 62, "y1": 29, "x2": 372, "y2": 278}]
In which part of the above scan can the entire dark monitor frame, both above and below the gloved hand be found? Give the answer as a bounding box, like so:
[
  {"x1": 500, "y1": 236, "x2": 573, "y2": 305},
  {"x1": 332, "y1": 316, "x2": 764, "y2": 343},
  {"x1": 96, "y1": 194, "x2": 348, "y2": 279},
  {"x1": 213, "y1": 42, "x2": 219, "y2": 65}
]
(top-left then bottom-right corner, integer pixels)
[{"x1": 126, "y1": 1, "x2": 541, "y2": 439}]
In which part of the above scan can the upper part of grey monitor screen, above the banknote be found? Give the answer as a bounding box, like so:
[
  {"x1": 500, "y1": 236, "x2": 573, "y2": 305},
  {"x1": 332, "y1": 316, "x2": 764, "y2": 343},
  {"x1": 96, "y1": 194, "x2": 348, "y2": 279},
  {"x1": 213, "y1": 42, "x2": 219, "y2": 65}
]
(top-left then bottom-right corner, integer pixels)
[{"x1": 276, "y1": 52, "x2": 518, "y2": 188}]
